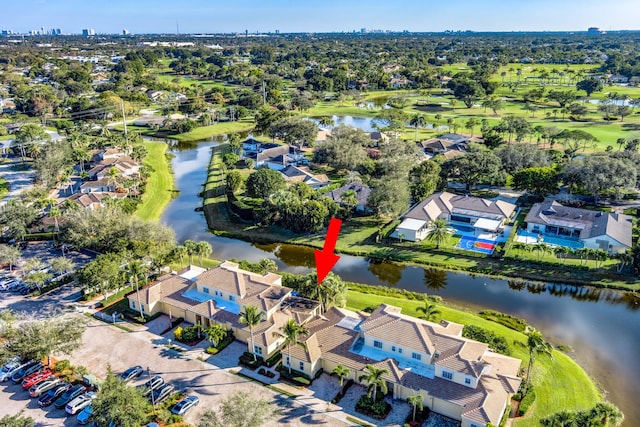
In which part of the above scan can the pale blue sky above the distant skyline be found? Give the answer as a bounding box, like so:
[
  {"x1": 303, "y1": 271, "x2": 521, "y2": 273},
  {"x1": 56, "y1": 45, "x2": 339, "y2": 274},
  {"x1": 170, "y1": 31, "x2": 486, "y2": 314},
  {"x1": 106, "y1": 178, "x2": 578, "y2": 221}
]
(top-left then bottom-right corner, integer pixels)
[{"x1": 0, "y1": 0, "x2": 640, "y2": 34}]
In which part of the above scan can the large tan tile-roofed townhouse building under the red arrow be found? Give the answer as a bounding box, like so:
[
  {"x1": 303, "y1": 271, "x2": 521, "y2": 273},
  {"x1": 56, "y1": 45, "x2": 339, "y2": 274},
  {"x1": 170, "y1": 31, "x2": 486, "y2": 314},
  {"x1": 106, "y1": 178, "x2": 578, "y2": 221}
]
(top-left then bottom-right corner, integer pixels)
[{"x1": 127, "y1": 261, "x2": 521, "y2": 427}]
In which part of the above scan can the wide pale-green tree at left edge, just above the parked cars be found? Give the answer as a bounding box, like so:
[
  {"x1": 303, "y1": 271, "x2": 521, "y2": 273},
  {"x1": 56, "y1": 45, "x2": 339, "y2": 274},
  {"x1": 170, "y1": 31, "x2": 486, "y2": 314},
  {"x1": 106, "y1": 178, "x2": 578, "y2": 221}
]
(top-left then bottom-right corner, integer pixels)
[{"x1": 0, "y1": 312, "x2": 87, "y2": 366}]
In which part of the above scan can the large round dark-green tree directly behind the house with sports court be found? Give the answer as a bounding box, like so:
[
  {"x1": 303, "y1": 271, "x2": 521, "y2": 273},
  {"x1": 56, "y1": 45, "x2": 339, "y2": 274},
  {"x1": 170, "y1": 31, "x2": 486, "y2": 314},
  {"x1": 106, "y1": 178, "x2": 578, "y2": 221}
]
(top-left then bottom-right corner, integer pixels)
[{"x1": 443, "y1": 151, "x2": 504, "y2": 190}]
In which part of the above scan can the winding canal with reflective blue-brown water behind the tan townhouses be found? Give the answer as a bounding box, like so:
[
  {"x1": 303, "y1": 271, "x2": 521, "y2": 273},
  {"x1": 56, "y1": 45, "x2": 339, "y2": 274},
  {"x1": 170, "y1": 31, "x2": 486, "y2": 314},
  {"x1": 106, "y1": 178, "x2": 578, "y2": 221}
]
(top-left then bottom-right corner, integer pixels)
[{"x1": 162, "y1": 141, "x2": 640, "y2": 426}]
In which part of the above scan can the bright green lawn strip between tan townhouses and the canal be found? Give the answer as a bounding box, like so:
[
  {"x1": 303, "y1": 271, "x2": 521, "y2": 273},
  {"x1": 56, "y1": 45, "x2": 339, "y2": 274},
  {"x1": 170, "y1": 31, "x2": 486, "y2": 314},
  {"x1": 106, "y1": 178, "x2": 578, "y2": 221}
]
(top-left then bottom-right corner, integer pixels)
[{"x1": 347, "y1": 290, "x2": 601, "y2": 427}]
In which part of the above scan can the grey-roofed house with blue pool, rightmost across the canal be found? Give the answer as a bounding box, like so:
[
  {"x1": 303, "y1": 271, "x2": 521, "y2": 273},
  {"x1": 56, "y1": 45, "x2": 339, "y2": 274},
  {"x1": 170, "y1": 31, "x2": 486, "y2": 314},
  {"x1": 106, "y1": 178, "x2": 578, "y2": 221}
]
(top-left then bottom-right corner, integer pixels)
[{"x1": 525, "y1": 200, "x2": 633, "y2": 253}]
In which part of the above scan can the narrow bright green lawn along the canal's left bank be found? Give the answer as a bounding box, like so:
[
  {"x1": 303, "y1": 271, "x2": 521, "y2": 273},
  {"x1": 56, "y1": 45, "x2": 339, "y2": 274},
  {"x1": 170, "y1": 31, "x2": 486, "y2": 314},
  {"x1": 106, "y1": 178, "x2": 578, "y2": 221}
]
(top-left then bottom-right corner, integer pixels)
[{"x1": 136, "y1": 142, "x2": 173, "y2": 221}]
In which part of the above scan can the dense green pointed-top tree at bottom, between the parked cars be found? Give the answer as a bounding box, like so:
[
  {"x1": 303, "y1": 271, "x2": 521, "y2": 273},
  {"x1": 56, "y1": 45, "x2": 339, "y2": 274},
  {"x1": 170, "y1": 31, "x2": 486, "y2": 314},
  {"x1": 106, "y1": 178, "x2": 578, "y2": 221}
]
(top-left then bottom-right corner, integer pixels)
[{"x1": 91, "y1": 366, "x2": 149, "y2": 426}]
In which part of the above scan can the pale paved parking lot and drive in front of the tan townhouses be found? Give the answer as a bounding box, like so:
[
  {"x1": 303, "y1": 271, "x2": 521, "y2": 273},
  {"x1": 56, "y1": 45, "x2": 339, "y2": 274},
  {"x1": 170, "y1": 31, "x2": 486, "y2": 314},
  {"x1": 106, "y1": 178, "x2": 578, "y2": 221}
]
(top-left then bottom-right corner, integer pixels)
[{"x1": 0, "y1": 320, "x2": 344, "y2": 427}]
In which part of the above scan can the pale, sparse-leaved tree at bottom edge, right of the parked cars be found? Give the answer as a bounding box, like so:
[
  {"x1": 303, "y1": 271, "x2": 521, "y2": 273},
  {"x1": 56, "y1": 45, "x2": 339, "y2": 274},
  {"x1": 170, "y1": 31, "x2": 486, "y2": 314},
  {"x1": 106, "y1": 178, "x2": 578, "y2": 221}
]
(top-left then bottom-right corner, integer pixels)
[{"x1": 197, "y1": 391, "x2": 275, "y2": 427}]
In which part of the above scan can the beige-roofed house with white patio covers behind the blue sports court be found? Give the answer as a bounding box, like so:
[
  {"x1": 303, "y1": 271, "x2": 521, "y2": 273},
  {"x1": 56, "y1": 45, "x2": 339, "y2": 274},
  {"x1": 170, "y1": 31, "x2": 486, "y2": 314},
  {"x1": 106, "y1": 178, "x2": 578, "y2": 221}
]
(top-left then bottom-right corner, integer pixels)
[{"x1": 391, "y1": 192, "x2": 516, "y2": 242}]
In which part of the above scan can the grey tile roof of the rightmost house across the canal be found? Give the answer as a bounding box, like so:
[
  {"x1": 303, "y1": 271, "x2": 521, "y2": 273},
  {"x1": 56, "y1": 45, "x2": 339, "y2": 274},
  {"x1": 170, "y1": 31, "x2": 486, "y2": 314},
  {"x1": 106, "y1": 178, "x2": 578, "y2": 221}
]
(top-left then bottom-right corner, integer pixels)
[{"x1": 525, "y1": 200, "x2": 633, "y2": 247}]
